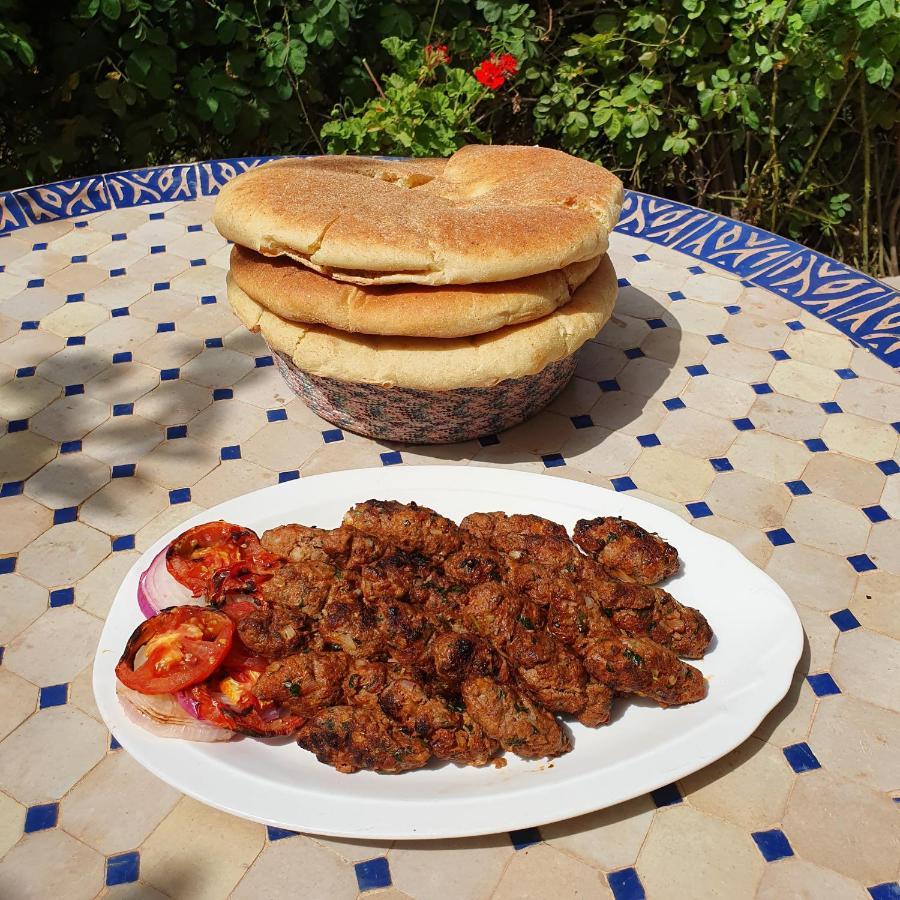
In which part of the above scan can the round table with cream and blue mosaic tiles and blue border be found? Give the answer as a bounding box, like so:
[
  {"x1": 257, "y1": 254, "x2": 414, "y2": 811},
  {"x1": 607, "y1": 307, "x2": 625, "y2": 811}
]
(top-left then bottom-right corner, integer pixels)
[{"x1": 0, "y1": 160, "x2": 900, "y2": 900}]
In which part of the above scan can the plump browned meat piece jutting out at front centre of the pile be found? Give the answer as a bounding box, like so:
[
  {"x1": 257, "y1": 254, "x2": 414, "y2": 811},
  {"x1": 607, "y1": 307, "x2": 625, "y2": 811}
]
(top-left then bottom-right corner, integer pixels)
[{"x1": 462, "y1": 676, "x2": 572, "y2": 758}]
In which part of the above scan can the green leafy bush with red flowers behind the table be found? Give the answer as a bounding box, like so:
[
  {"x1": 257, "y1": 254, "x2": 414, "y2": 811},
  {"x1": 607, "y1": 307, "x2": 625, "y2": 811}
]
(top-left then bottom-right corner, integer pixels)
[{"x1": 0, "y1": 0, "x2": 900, "y2": 273}]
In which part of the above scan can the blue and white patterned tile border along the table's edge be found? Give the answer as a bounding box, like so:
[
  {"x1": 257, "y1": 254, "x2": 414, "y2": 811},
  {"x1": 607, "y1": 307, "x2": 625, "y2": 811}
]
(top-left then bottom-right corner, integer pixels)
[{"x1": 0, "y1": 156, "x2": 900, "y2": 368}]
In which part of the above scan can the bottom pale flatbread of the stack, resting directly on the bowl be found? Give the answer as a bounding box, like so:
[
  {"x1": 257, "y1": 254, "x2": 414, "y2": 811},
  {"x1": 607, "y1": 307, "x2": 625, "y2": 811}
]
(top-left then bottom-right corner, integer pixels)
[{"x1": 228, "y1": 256, "x2": 618, "y2": 391}]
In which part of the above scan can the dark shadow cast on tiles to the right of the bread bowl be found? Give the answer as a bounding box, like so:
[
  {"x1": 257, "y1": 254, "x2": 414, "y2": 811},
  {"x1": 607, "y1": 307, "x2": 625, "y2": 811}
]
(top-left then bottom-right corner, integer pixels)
[{"x1": 378, "y1": 286, "x2": 684, "y2": 474}]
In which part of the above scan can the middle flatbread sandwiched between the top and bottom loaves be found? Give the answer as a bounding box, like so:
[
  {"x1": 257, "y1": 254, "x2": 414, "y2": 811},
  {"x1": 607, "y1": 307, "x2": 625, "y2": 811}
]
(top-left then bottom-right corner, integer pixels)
[{"x1": 231, "y1": 244, "x2": 600, "y2": 338}]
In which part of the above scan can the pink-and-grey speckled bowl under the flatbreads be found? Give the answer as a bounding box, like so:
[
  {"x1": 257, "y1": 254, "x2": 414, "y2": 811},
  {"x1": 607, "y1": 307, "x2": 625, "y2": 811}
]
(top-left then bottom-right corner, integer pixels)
[{"x1": 272, "y1": 350, "x2": 575, "y2": 444}]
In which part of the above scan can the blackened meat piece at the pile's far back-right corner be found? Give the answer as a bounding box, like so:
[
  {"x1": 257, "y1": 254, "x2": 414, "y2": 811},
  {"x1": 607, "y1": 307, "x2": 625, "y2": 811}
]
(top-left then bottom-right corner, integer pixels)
[{"x1": 575, "y1": 516, "x2": 678, "y2": 584}]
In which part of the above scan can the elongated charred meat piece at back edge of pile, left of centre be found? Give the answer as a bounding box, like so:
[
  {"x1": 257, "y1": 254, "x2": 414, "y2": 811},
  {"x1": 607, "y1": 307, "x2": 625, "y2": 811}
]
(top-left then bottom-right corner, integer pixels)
[{"x1": 344, "y1": 500, "x2": 462, "y2": 559}]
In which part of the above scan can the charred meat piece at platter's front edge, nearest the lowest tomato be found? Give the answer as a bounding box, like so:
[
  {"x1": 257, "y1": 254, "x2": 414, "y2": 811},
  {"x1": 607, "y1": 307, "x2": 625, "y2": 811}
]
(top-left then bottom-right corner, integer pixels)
[{"x1": 297, "y1": 706, "x2": 431, "y2": 773}]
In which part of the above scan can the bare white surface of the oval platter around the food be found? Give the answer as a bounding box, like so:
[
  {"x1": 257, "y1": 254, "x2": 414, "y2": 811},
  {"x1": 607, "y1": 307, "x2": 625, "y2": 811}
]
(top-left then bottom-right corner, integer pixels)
[{"x1": 93, "y1": 466, "x2": 803, "y2": 839}]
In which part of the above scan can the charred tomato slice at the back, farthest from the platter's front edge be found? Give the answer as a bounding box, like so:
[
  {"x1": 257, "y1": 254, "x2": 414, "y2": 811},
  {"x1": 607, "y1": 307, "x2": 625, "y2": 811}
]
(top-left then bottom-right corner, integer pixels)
[{"x1": 166, "y1": 520, "x2": 268, "y2": 597}]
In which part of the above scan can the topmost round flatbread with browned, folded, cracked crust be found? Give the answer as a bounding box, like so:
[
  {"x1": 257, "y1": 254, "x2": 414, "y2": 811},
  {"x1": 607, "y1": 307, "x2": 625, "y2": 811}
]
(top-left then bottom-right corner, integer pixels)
[{"x1": 214, "y1": 145, "x2": 622, "y2": 284}]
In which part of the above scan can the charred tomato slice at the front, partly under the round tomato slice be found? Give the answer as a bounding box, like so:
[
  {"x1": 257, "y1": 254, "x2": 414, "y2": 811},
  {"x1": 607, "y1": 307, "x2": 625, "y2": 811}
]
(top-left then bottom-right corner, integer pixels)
[{"x1": 191, "y1": 637, "x2": 306, "y2": 737}]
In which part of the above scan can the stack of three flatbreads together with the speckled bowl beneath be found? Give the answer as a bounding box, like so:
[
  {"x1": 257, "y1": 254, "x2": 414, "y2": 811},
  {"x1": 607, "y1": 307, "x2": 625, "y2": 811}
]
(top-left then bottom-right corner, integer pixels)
[{"x1": 215, "y1": 146, "x2": 622, "y2": 443}]
